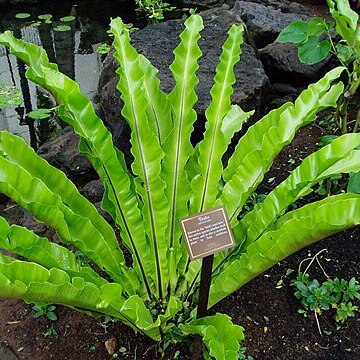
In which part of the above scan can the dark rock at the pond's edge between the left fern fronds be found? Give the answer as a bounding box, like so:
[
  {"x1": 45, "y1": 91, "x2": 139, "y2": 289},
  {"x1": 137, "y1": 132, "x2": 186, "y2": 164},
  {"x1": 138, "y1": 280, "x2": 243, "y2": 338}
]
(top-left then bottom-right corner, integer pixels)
[{"x1": 38, "y1": 127, "x2": 96, "y2": 185}]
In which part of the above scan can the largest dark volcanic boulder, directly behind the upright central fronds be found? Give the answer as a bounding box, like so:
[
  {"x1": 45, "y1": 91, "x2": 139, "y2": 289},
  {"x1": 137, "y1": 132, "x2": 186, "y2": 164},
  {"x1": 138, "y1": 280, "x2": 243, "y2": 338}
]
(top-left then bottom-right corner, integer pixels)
[{"x1": 99, "y1": 8, "x2": 269, "y2": 147}]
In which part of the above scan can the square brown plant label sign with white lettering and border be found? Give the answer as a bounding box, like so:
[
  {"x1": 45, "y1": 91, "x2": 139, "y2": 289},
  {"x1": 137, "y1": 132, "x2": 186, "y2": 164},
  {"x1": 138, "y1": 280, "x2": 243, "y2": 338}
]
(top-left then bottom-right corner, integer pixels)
[{"x1": 180, "y1": 206, "x2": 236, "y2": 260}]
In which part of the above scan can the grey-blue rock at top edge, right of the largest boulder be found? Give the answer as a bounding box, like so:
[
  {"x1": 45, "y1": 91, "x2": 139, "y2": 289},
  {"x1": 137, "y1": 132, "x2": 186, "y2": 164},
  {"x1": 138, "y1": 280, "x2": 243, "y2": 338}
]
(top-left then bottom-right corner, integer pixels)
[{"x1": 231, "y1": 1, "x2": 310, "y2": 49}]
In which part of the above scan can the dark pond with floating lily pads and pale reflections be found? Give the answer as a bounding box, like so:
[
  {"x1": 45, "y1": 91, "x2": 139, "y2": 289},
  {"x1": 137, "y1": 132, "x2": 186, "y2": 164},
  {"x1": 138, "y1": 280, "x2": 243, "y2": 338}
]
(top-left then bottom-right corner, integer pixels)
[{"x1": 0, "y1": 0, "x2": 187, "y2": 149}]
